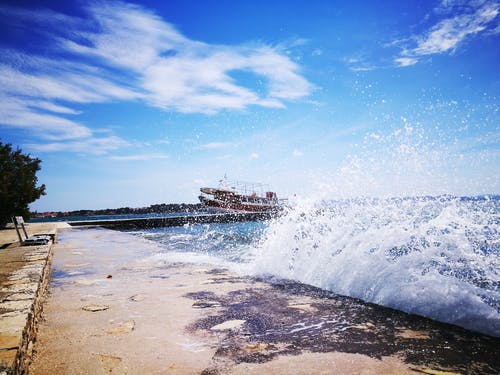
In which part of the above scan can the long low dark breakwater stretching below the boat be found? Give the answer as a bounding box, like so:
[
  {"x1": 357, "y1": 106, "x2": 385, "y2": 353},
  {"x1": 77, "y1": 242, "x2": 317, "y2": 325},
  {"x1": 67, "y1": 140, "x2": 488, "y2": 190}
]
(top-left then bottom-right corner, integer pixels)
[{"x1": 68, "y1": 212, "x2": 276, "y2": 230}]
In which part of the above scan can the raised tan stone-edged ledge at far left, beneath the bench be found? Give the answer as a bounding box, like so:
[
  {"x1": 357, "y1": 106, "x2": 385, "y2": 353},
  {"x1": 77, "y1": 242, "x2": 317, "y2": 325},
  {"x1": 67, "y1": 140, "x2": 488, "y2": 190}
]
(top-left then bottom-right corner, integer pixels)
[{"x1": 0, "y1": 223, "x2": 67, "y2": 375}]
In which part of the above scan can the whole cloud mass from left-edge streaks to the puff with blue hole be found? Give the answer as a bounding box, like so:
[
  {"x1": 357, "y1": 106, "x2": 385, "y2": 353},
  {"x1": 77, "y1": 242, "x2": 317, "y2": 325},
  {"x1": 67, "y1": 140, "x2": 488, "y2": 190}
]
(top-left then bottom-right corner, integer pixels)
[{"x1": 0, "y1": 2, "x2": 313, "y2": 152}]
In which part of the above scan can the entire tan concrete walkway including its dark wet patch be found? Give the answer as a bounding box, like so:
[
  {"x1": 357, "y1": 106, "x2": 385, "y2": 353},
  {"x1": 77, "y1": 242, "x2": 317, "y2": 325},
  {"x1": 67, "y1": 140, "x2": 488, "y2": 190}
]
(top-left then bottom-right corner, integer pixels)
[{"x1": 26, "y1": 230, "x2": 500, "y2": 374}]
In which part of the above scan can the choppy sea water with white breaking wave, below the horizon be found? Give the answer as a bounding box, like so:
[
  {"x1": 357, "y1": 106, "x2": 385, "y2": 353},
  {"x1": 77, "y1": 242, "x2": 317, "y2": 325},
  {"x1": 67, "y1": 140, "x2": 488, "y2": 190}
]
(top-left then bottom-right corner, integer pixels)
[{"x1": 132, "y1": 195, "x2": 500, "y2": 336}]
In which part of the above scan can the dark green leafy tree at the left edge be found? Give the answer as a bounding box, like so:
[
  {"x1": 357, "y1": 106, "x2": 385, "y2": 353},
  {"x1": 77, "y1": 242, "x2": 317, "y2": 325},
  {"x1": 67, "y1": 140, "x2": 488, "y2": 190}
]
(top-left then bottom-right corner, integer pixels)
[{"x1": 0, "y1": 141, "x2": 45, "y2": 226}]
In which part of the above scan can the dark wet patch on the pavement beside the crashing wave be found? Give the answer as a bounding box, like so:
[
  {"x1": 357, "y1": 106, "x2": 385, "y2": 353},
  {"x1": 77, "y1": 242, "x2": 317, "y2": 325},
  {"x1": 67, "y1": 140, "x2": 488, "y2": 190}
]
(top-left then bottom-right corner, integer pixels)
[{"x1": 186, "y1": 279, "x2": 500, "y2": 374}]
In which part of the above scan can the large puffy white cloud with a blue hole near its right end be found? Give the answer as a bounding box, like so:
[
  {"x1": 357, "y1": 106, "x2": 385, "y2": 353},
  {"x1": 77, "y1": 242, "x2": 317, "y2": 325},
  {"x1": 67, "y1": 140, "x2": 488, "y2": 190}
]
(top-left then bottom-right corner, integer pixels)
[{"x1": 62, "y1": 3, "x2": 312, "y2": 113}]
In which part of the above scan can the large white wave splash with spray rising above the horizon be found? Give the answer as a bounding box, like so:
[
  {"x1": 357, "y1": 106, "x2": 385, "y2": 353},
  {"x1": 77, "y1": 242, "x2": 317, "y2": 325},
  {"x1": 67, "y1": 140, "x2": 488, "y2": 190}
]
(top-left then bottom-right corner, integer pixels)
[{"x1": 248, "y1": 124, "x2": 500, "y2": 336}]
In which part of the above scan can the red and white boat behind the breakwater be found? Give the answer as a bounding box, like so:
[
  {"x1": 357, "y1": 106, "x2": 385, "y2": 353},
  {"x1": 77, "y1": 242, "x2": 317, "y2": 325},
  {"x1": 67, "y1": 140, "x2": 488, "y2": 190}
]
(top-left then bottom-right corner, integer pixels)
[{"x1": 199, "y1": 179, "x2": 284, "y2": 212}]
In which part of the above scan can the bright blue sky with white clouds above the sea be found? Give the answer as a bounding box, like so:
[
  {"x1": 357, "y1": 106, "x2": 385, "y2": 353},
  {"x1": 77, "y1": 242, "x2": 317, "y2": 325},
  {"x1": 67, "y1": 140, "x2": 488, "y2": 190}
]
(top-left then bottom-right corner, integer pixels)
[{"x1": 0, "y1": 0, "x2": 500, "y2": 211}]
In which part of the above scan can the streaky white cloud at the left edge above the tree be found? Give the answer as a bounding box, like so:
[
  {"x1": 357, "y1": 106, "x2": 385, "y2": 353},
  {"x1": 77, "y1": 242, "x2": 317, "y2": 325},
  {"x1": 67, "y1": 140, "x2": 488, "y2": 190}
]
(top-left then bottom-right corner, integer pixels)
[{"x1": 0, "y1": 51, "x2": 138, "y2": 145}]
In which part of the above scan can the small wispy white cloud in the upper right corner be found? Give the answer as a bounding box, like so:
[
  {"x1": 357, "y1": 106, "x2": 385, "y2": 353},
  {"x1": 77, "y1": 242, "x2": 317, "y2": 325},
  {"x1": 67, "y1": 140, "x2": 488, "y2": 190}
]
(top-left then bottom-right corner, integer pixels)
[{"x1": 394, "y1": 1, "x2": 500, "y2": 66}]
